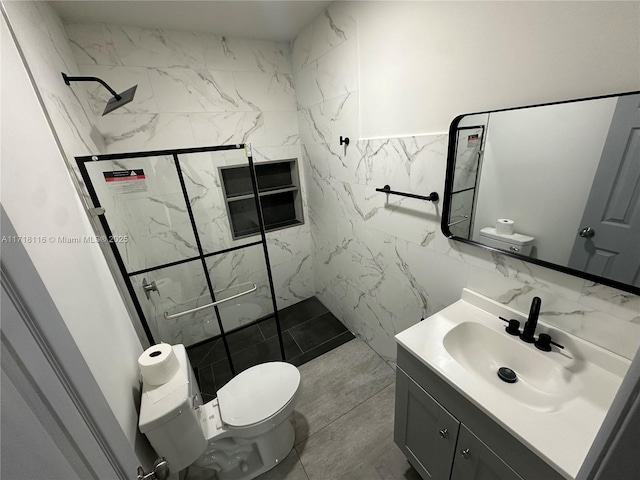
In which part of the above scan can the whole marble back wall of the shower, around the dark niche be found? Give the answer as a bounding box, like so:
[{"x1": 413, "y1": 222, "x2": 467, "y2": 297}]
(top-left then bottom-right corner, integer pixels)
[{"x1": 65, "y1": 24, "x2": 315, "y2": 344}]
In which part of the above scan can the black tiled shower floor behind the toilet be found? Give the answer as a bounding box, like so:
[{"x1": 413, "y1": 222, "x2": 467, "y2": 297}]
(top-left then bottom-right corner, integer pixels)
[{"x1": 192, "y1": 297, "x2": 355, "y2": 402}]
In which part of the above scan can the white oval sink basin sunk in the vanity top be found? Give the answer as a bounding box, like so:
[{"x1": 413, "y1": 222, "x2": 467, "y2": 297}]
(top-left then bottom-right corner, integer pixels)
[{"x1": 443, "y1": 322, "x2": 582, "y2": 412}]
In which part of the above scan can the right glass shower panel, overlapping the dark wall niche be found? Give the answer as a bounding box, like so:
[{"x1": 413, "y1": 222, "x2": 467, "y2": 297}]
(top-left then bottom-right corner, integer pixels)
[{"x1": 180, "y1": 151, "x2": 282, "y2": 378}]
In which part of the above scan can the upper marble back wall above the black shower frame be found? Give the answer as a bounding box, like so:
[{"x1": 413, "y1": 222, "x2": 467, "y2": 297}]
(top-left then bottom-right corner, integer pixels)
[{"x1": 65, "y1": 24, "x2": 298, "y2": 156}]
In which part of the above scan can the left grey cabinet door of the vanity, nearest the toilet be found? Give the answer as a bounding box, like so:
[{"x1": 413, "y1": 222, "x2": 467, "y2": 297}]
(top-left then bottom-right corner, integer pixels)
[{"x1": 394, "y1": 368, "x2": 460, "y2": 480}]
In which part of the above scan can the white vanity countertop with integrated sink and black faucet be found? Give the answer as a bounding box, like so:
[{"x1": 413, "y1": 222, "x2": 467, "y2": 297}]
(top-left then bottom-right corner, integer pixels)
[{"x1": 396, "y1": 289, "x2": 631, "y2": 479}]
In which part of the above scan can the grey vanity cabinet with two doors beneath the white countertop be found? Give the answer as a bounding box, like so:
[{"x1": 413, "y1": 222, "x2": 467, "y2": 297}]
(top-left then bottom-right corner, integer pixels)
[{"x1": 394, "y1": 345, "x2": 564, "y2": 480}]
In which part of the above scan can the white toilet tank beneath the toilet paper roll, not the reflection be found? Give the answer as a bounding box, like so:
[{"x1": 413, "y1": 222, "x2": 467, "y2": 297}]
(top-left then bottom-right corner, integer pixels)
[{"x1": 138, "y1": 345, "x2": 207, "y2": 472}]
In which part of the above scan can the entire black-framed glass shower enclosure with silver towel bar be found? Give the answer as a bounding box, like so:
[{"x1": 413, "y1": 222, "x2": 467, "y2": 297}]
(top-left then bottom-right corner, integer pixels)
[{"x1": 76, "y1": 144, "x2": 285, "y2": 375}]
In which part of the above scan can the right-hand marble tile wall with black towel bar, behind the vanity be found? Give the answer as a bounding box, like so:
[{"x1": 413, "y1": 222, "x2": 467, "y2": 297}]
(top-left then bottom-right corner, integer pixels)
[{"x1": 292, "y1": 2, "x2": 640, "y2": 364}]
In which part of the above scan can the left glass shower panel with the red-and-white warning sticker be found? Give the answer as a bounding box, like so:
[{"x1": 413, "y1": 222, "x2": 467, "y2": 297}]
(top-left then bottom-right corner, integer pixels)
[{"x1": 86, "y1": 155, "x2": 220, "y2": 345}]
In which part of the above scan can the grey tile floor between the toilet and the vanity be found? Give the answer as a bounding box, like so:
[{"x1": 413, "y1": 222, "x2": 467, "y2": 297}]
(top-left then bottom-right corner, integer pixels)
[{"x1": 258, "y1": 338, "x2": 420, "y2": 480}]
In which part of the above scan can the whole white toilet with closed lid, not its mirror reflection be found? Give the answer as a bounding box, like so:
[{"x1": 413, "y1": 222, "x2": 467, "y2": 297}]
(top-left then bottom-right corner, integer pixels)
[{"x1": 138, "y1": 345, "x2": 300, "y2": 480}]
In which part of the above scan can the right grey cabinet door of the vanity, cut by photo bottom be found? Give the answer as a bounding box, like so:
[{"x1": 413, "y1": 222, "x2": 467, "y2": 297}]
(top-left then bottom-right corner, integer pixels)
[{"x1": 451, "y1": 425, "x2": 522, "y2": 480}]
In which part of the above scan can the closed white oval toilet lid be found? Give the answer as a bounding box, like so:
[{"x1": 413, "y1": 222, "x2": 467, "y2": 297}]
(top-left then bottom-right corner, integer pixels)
[{"x1": 218, "y1": 362, "x2": 300, "y2": 427}]
